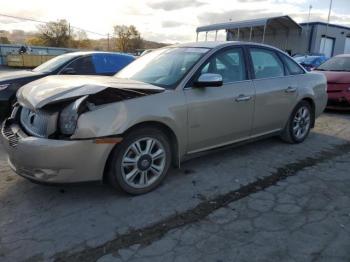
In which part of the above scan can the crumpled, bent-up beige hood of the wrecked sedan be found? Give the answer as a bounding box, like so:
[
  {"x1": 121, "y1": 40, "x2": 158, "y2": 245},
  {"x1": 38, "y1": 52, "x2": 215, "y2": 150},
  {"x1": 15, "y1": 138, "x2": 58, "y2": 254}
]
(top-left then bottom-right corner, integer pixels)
[{"x1": 17, "y1": 76, "x2": 164, "y2": 109}]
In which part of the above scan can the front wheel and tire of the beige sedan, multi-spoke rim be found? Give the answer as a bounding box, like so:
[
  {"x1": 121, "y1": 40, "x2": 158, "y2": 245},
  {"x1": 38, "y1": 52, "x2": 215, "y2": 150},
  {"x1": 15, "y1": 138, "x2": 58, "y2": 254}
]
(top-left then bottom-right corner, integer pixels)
[{"x1": 108, "y1": 127, "x2": 171, "y2": 195}]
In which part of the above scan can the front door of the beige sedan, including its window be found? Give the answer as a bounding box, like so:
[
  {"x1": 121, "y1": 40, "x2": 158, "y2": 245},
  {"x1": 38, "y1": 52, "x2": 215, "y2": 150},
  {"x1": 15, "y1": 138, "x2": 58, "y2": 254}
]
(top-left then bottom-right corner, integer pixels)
[{"x1": 184, "y1": 48, "x2": 255, "y2": 153}]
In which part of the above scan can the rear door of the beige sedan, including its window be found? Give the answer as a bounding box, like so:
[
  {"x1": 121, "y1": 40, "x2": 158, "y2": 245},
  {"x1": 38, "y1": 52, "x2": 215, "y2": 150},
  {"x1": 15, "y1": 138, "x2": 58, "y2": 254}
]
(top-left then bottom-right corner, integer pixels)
[{"x1": 249, "y1": 47, "x2": 298, "y2": 136}]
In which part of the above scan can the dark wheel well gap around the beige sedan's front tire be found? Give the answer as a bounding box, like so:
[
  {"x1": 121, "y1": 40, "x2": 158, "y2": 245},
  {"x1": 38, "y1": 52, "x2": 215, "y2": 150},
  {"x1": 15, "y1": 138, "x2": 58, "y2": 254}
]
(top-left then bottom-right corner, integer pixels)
[{"x1": 103, "y1": 121, "x2": 179, "y2": 182}]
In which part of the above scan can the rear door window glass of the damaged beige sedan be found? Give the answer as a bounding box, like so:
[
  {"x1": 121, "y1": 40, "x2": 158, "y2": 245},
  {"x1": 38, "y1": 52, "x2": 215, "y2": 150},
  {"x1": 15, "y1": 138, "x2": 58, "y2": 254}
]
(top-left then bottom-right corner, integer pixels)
[{"x1": 250, "y1": 48, "x2": 284, "y2": 79}]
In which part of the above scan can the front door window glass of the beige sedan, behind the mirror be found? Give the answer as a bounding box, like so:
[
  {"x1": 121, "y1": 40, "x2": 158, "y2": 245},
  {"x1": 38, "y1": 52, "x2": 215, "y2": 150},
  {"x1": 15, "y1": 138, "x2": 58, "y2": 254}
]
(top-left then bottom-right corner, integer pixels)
[{"x1": 201, "y1": 48, "x2": 247, "y2": 84}]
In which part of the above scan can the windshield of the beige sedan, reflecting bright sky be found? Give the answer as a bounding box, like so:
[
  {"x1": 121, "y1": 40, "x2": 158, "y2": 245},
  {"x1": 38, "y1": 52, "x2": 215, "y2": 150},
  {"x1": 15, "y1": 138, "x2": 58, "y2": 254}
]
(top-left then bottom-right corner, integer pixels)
[{"x1": 116, "y1": 47, "x2": 209, "y2": 89}]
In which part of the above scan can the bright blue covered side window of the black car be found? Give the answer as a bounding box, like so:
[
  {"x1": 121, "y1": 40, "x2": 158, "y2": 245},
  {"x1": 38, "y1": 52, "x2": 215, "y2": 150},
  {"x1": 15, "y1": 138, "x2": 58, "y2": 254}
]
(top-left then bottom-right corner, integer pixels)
[{"x1": 92, "y1": 54, "x2": 134, "y2": 75}]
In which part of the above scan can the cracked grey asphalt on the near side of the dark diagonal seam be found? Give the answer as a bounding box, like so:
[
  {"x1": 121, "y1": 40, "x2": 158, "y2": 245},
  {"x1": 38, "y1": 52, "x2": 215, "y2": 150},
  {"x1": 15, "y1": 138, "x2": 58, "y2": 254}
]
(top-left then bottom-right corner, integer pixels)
[{"x1": 98, "y1": 153, "x2": 350, "y2": 262}]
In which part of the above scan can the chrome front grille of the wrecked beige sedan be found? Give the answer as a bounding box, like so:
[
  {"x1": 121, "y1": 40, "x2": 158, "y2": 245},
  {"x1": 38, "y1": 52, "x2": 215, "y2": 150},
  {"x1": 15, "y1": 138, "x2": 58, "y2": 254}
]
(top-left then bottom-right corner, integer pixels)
[{"x1": 20, "y1": 107, "x2": 58, "y2": 138}]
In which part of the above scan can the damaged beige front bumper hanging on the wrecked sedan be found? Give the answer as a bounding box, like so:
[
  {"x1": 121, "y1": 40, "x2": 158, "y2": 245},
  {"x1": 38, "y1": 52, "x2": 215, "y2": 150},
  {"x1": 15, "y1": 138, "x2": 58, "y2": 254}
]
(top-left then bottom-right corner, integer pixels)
[{"x1": 1, "y1": 119, "x2": 113, "y2": 183}]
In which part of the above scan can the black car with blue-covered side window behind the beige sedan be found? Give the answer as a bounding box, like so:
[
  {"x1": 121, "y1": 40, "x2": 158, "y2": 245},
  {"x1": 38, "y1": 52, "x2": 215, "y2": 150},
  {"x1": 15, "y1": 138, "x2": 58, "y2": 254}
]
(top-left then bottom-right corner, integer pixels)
[{"x1": 0, "y1": 52, "x2": 134, "y2": 118}]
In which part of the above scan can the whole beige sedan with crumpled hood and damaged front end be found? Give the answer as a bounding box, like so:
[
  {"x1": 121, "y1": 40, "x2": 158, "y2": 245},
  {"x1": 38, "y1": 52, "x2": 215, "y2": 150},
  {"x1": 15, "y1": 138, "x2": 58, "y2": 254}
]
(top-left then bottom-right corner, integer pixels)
[{"x1": 2, "y1": 42, "x2": 327, "y2": 194}]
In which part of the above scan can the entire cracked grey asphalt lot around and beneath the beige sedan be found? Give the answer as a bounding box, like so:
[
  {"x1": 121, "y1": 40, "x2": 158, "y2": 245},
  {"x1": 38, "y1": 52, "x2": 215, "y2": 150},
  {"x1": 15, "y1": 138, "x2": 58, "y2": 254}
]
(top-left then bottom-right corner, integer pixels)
[{"x1": 0, "y1": 112, "x2": 350, "y2": 261}]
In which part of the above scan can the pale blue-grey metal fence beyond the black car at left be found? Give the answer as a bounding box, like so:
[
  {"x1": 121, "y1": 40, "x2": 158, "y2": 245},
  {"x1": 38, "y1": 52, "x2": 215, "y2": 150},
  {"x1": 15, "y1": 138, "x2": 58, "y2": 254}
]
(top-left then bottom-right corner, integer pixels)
[{"x1": 0, "y1": 44, "x2": 78, "y2": 65}]
